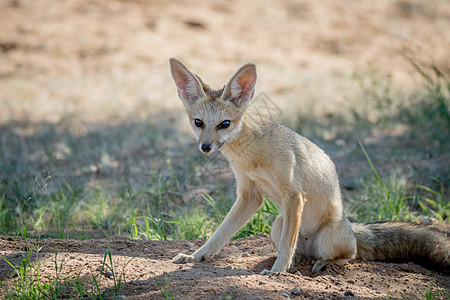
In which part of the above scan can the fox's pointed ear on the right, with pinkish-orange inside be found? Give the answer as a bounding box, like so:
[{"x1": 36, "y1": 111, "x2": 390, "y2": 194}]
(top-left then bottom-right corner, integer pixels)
[{"x1": 222, "y1": 63, "x2": 256, "y2": 108}]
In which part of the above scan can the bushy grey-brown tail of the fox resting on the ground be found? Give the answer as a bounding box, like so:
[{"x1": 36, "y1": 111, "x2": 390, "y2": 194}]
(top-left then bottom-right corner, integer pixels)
[{"x1": 352, "y1": 222, "x2": 450, "y2": 271}]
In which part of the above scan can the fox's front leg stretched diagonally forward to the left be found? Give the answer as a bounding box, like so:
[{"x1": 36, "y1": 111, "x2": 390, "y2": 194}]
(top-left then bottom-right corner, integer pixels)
[{"x1": 172, "y1": 180, "x2": 263, "y2": 264}]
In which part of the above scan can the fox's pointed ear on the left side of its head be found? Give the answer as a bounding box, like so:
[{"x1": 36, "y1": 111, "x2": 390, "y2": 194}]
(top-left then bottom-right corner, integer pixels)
[{"x1": 169, "y1": 58, "x2": 206, "y2": 107}]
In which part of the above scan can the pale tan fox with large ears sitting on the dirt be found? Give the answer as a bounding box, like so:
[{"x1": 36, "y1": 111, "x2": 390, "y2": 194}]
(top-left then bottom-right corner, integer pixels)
[{"x1": 169, "y1": 58, "x2": 450, "y2": 275}]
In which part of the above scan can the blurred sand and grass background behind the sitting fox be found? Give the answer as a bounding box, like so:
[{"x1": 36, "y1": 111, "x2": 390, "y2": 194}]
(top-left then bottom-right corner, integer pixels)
[{"x1": 0, "y1": 0, "x2": 450, "y2": 239}]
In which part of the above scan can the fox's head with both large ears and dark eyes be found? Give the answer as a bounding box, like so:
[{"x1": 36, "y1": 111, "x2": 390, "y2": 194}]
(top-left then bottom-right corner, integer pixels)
[{"x1": 169, "y1": 58, "x2": 256, "y2": 154}]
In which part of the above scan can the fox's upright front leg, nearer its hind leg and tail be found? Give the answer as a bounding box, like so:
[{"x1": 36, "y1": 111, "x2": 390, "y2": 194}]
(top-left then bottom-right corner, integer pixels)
[{"x1": 261, "y1": 194, "x2": 305, "y2": 275}]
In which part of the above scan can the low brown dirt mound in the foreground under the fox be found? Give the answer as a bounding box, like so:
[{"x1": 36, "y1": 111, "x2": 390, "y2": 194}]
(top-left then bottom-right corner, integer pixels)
[{"x1": 0, "y1": 235, "x2": 450, "y2": 299}]
